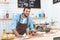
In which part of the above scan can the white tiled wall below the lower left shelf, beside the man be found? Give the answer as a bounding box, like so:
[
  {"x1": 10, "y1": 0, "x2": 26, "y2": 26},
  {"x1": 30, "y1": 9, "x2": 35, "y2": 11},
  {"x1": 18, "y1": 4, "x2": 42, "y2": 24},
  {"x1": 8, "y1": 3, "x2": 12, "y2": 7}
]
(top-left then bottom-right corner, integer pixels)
[{"x1": 0, "y1": 20, "x2": 12, "y2": 34}]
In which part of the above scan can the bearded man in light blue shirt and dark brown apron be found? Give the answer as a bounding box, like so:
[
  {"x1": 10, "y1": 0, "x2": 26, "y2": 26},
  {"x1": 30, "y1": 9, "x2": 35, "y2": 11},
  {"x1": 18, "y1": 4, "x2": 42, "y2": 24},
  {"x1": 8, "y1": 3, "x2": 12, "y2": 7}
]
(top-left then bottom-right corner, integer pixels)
[{"x1": 12, "y1": 7, "x2": 34, "y2": 37}]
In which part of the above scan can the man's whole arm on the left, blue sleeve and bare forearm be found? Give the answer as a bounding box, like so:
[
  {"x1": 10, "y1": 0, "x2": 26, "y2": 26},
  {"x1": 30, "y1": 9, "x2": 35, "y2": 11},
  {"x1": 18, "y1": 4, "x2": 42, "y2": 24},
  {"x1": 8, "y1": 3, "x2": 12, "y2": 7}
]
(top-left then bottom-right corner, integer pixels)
[{"x1": 11, "y1": 14, "x2": 21, "y2": 36}]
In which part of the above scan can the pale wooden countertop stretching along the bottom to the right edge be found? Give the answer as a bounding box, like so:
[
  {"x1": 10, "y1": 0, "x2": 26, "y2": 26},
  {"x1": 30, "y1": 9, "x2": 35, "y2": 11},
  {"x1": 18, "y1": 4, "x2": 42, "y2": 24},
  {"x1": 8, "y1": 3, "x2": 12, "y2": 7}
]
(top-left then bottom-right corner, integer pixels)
[{"x1": 0, "y1": 30, "x2": 60, "y2": 40}]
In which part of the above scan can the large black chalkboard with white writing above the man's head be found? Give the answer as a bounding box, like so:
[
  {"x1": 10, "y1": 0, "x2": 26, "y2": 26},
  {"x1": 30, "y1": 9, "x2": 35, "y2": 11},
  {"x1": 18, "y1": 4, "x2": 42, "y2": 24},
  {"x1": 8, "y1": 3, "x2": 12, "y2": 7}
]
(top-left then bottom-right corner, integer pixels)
[{"x1": 18, "y1": 0, "x2": 41, "y2": 8}]
